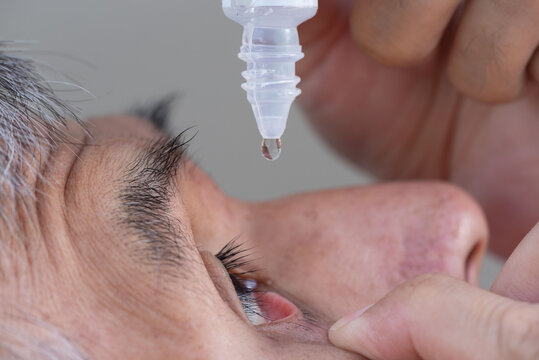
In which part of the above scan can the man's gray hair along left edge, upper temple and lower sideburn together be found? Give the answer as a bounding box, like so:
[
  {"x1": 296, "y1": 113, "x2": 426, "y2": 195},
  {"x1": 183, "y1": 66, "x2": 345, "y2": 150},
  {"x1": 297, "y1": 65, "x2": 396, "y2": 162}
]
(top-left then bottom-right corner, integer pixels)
[{"x1": 0, "y1": 41, "x2": 85, "y2": 360}]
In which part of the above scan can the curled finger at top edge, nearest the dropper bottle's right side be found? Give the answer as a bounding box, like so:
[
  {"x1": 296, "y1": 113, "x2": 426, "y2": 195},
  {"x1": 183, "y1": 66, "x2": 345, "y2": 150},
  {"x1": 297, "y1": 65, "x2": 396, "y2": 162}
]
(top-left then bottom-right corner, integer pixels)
[{"x1": 350, "y1": 0, "x2": 460, "y2": 65}]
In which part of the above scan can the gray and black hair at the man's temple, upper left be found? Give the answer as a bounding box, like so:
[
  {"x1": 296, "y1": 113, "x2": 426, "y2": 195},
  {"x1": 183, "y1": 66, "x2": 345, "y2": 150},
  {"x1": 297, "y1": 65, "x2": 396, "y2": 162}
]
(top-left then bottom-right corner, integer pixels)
[{"x1": 0, "y1": 41, "x2": 78, "y2": 230}]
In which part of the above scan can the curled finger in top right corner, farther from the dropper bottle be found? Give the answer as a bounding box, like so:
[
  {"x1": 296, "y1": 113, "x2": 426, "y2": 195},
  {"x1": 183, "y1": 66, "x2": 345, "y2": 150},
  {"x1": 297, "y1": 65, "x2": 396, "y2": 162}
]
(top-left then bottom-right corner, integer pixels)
[{"x1": 448, "y1": 0, "x2": 539, "y2": 102}]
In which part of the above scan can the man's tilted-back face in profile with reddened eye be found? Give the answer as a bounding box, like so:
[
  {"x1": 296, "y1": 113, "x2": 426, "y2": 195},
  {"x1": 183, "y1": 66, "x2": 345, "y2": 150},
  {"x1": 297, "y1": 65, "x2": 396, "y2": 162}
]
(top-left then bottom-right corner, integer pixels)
[{"x1": 0, "y1": 117, "x2": 487, "y2": 359}]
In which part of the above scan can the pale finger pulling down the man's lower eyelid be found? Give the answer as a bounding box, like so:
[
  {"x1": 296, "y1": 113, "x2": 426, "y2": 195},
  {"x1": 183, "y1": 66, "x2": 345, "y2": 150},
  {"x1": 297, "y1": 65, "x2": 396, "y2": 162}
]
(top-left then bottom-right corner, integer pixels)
[{"x1": 329, "y1": 275, "x2": 539, "y2": 360}]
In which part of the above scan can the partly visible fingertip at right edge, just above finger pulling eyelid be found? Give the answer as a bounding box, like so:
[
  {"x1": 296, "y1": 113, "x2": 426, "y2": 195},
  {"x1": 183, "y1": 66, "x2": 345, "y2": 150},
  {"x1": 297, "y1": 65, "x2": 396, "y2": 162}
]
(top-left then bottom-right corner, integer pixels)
[{"x1": 491, "y1": 223, "x2": 539, "y2": 303}]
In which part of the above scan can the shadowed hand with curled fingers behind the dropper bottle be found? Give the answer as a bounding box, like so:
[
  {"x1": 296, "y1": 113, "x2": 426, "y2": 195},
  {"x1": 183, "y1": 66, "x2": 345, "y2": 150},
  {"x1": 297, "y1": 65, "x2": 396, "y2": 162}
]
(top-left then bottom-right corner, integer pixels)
[{"x1": 298, "y1": 0, "x2": 539, "y2": 256}]
